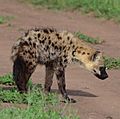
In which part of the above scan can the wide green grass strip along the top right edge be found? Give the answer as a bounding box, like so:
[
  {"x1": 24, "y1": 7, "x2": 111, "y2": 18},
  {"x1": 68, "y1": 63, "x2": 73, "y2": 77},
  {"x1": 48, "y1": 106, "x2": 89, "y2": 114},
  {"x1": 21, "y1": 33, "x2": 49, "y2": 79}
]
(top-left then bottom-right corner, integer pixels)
[{"x1": 23, "y1": 0, "x2": 120, "y2": 21}]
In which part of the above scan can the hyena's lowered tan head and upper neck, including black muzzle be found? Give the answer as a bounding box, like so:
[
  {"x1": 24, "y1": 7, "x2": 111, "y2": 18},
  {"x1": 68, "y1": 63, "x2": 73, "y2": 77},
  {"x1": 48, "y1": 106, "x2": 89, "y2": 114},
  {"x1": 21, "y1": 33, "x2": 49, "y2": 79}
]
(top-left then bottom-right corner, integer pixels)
[{"x1": 75, "y1": 47, "x2": 108, "y2": 80}]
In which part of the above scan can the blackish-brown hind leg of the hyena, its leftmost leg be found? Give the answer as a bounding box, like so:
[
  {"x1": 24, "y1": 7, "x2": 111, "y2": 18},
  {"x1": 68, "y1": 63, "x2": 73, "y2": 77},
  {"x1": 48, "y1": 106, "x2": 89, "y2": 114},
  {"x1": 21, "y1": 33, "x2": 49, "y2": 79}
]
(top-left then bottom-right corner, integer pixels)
[{"x1": 13, "y1": 56, "x2": 31, "y2": 93}]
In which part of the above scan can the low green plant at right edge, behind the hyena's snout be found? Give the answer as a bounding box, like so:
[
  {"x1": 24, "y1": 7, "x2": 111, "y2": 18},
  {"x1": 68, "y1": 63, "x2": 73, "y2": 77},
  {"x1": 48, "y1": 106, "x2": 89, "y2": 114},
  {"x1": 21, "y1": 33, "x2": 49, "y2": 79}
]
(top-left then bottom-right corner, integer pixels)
[{"x1": 104, "y1": 57, "x2": 120, "y2": 69}]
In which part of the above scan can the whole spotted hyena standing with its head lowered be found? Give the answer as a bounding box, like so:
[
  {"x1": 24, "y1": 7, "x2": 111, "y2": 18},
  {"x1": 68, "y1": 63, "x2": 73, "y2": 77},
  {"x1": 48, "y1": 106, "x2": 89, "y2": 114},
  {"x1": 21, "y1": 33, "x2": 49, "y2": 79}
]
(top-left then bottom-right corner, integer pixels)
[{"x1": 11, "y1": 28, "x2": 108, "y2": 102}]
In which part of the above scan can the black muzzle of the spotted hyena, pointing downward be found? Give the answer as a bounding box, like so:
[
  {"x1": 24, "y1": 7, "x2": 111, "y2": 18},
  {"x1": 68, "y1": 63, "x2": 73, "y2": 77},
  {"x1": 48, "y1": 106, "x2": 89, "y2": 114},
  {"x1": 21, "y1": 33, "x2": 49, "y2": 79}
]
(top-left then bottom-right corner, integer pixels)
[{"x1": 94, "y1": 67, "x2": 108, "y2": 80}]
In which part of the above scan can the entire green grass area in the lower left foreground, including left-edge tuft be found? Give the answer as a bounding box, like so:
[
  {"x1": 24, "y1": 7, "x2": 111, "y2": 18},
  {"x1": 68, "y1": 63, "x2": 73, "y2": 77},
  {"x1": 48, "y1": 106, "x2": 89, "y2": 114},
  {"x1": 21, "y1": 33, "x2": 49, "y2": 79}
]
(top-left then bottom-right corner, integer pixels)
[{"x1": 0, "y1": 74, "x2": 80, "y2": 119}]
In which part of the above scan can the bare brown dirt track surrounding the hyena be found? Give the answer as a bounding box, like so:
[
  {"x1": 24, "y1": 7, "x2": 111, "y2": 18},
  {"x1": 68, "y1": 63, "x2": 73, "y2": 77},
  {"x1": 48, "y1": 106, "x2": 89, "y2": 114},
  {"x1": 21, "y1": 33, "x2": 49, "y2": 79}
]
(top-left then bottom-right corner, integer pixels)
[{"x1": 0, "y1": 0, "x2": 120, "y2": 119}]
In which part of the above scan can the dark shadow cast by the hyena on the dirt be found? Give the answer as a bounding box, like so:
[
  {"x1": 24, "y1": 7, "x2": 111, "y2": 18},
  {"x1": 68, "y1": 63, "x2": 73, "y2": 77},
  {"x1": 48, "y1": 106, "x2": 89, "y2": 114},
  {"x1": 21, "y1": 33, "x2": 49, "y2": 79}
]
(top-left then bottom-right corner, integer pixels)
[{"x1": 52, "y1": 89, "x2": 98, "y2": 97}]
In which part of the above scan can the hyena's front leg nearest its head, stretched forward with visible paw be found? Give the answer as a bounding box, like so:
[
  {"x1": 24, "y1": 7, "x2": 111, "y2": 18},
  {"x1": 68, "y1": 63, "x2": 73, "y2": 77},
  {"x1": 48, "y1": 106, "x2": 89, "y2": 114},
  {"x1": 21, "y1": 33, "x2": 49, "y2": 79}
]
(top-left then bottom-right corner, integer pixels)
[{"x1": 55, "y1": 67, "x2": 76, "y2": 103}]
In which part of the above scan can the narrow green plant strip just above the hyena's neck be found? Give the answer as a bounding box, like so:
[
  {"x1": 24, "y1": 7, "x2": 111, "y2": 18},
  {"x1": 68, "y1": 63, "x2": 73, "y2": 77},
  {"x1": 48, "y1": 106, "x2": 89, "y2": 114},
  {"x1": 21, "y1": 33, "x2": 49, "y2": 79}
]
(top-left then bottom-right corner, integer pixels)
[{"x1": 75, "y1": 32, "x2": 104, "y2": 44}]
